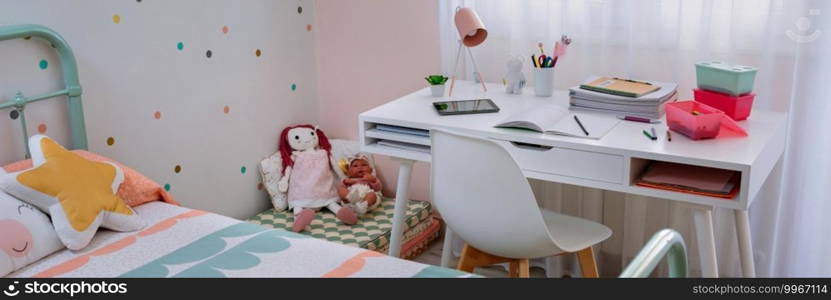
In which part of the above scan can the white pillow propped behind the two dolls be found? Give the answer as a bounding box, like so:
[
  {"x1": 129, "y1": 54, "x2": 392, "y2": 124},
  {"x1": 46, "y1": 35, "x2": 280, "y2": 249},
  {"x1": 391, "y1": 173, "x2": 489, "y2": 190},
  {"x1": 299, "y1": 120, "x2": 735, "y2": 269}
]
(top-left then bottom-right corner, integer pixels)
[{"x1": 260, "y1": 139, "x2": 375, "y2": 211}]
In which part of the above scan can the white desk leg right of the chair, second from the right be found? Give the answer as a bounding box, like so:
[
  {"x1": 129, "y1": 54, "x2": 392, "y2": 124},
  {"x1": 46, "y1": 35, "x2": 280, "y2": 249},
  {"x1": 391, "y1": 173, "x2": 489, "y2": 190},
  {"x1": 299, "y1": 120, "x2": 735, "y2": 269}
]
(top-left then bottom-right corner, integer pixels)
[{"x1": 692, "y1": 207, "x2": 718, "y2": 278}]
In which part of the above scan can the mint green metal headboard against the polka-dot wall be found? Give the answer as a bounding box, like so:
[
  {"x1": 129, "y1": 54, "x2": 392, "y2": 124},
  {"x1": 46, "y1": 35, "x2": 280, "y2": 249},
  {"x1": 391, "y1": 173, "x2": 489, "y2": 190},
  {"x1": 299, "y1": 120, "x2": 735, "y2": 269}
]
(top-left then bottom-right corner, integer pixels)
[{"x1": 0, "y1": 25, "x2": 88, "y2": 157}]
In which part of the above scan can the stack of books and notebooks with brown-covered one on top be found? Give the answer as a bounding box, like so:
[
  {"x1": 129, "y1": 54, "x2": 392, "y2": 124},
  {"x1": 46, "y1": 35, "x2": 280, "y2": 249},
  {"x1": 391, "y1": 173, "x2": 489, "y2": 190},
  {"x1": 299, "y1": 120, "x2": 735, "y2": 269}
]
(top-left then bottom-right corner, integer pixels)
[{"x1": 569, "y1": 76, "x2": 678, "y2": 119}]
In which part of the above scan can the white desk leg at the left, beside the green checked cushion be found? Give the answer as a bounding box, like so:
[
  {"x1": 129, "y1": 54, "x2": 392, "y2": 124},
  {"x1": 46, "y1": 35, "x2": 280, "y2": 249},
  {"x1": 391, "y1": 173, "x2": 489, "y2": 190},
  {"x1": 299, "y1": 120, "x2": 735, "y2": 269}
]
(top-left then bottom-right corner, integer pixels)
[{"x1": 388, "y1": 159, "x2": 415, "y2": 257}]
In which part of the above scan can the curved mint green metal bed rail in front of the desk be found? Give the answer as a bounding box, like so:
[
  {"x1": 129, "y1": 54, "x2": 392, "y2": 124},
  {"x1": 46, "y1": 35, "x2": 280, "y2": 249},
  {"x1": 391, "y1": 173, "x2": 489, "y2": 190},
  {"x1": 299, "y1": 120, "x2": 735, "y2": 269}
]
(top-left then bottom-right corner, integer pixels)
[{"x1": 620, "y1": 229, "x2": 687, "y2": 278}]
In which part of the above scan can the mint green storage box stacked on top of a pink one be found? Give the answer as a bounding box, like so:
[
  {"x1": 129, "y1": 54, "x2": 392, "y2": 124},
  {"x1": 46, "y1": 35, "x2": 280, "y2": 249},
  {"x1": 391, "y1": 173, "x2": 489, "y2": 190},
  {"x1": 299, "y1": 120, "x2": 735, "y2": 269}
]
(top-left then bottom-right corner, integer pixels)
[{"x1": 695, "y1": 61, "x2": 756, "y2": 96}]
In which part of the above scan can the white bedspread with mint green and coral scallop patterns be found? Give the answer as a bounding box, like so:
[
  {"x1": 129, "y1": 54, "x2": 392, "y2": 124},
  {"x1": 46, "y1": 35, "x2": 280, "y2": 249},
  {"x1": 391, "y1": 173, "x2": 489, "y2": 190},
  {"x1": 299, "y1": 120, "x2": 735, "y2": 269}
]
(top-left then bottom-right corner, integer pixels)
[{"x1": 9, "y1": 202, "x2": 472, "y2": 277}]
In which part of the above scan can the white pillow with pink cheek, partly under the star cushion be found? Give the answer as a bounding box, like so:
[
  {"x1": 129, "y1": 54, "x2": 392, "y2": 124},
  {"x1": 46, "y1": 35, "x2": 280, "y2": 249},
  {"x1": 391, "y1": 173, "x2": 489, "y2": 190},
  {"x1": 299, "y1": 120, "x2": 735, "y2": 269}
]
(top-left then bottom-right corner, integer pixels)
[{"x1": 0, "y1": 168, "x2": 63, "y2": 277}]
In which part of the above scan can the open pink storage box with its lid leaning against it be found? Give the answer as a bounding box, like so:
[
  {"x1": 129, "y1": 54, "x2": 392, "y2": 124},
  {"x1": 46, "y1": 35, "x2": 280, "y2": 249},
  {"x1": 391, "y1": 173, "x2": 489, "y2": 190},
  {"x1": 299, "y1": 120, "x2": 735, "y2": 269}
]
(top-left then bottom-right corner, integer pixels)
[{"x1": 666, "y1": 100, "x2": 747, "y2": 140}]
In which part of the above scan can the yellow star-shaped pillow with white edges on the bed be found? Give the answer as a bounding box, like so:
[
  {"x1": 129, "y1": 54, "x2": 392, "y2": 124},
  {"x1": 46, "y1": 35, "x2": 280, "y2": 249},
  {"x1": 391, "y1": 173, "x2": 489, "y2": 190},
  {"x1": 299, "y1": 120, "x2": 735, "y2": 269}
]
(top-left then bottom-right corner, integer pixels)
[{"x1": 0, "y1": 135, "x2": 144, "y2": 250}]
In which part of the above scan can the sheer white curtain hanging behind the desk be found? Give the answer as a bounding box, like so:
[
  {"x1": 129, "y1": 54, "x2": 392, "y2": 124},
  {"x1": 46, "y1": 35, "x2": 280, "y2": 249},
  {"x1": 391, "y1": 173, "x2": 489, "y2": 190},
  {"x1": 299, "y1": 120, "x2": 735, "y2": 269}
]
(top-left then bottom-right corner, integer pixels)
[{"x1": 439, "y1": 0, "x2": 831, "y2": 276}]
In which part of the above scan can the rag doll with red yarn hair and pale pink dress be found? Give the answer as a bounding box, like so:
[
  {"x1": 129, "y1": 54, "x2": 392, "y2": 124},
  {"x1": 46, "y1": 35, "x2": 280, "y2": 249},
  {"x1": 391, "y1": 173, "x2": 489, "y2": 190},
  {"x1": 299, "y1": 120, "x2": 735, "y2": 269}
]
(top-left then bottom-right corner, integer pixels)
[{"x1": 278, "y1": 125, "x2": 358, "y2": 232}]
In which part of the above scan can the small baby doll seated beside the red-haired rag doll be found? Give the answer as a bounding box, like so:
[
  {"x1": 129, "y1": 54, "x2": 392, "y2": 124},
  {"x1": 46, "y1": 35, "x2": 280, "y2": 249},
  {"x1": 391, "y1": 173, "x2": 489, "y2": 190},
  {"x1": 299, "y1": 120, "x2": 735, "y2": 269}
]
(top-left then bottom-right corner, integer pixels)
[{"x1": 338, "y1": 154, "x2": 381, "y2": 215}]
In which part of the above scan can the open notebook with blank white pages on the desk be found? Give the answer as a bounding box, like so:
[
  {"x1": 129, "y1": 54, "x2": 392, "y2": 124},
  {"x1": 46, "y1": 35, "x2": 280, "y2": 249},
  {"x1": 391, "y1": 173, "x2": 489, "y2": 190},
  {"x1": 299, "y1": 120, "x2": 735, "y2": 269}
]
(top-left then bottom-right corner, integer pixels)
[{"x1": 496, "y1": 104, "x2": 620, "y2": 139}]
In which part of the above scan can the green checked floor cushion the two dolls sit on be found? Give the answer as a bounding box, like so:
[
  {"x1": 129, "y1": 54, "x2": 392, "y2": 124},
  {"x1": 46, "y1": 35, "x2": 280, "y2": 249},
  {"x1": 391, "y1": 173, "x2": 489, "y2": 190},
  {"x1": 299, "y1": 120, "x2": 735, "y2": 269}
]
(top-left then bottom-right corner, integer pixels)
[{"x1": 248, "y1": 197, "x2": 432, "y2": 257}]
